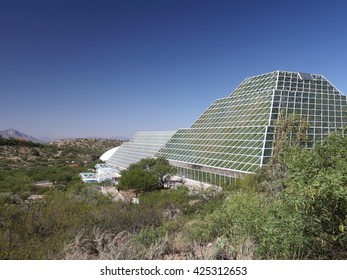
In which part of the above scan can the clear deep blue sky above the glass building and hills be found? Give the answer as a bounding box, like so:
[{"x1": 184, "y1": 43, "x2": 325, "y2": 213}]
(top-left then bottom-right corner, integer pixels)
[{"x1": 0, "y1": 0, "x2": 347, "y2": 137}]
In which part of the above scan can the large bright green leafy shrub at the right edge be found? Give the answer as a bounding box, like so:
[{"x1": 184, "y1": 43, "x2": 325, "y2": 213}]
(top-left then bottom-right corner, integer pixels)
[{"x1": 258, "y1": 134, "x2": 347, "y2": 259}]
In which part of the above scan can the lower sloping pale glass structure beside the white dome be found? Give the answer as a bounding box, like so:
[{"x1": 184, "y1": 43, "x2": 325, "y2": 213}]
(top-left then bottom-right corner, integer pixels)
[{"x1": 106, "y1": 131, "x2": 175, "y2": 170}]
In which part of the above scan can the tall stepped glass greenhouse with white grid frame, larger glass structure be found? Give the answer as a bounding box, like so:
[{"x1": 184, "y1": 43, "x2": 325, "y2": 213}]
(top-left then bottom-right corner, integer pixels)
[{"x1": 156, "y1": 71, "x2": 347, "y2": 185}]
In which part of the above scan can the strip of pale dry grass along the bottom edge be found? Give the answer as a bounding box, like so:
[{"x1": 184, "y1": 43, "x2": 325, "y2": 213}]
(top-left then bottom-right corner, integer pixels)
[{"x1": 61, "y1": 225, "x2": 254, "y2": 260}]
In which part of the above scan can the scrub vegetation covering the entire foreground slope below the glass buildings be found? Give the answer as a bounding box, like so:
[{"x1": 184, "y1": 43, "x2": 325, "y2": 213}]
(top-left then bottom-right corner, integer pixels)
[{"x1": 0, "y1": 131, "x2": 347, "y2": 259}]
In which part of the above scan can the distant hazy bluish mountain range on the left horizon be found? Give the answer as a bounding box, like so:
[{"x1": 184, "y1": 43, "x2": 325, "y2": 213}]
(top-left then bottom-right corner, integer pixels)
[{"x1": 0, "y1": 128, "x2": 129, "y2": 143}]
